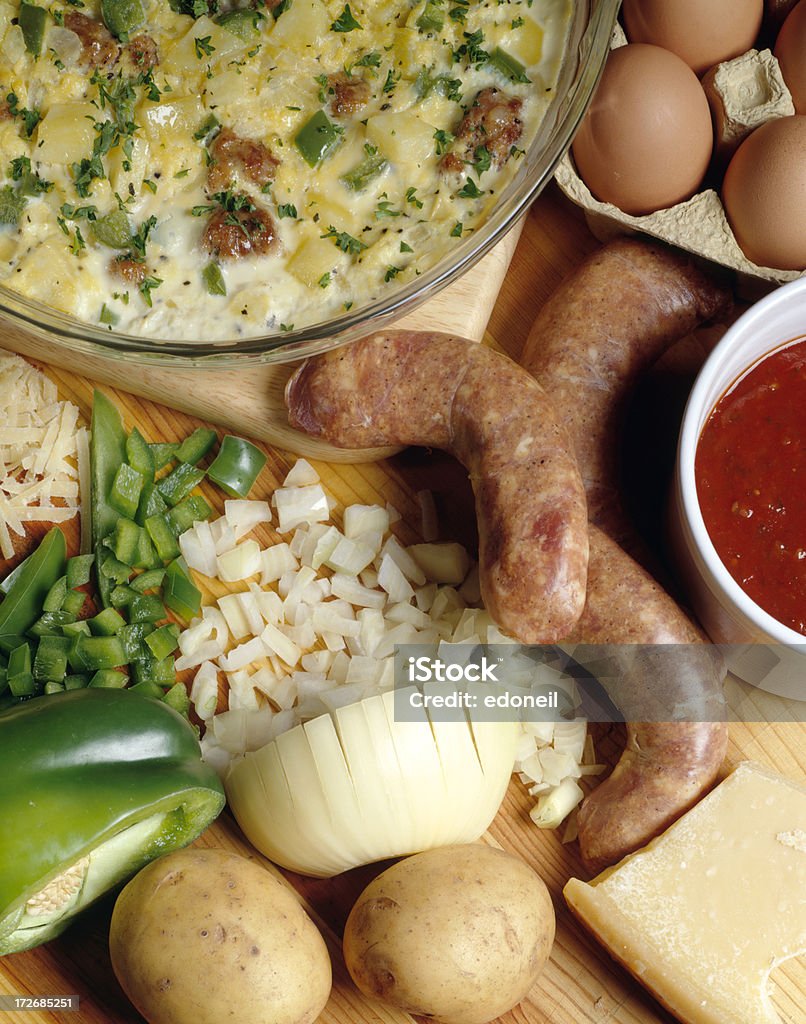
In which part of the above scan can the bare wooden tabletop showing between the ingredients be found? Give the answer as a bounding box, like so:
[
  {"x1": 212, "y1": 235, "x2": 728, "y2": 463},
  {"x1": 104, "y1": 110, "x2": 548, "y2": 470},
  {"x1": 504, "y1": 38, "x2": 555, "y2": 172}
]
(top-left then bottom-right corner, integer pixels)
[{"x1": 0, "y1": 187, "x2": 806, "y2": 1024}]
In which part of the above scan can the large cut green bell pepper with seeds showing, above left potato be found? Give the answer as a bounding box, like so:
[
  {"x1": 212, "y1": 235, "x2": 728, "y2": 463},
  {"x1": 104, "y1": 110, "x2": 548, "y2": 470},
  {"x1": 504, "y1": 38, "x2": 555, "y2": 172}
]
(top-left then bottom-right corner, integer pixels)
[{"x1": 0, "y1": 689, "x2": 224, "y2": 954}]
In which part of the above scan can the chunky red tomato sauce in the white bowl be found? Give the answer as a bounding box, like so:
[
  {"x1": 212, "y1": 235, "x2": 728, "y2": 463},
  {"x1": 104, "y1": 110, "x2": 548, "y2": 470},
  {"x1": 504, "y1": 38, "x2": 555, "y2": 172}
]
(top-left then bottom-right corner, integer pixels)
[{"x1": 694, "y1": 341, "x2": 806, "y2": 635}]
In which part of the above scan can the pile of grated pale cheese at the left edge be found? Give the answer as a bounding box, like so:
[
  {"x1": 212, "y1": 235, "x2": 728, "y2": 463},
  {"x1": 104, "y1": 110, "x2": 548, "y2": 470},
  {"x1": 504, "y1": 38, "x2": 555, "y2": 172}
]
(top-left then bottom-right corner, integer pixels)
[{"x1": 0, "y1": 352, "x2": 89, "y2": 558}]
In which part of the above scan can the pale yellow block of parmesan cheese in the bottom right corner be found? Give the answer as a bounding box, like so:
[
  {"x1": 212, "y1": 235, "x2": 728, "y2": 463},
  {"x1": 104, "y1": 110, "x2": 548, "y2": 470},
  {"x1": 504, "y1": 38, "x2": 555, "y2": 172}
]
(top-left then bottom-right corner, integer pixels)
[{"x1": 563, "y1": 762, "x2": 806, "y2": 1024}]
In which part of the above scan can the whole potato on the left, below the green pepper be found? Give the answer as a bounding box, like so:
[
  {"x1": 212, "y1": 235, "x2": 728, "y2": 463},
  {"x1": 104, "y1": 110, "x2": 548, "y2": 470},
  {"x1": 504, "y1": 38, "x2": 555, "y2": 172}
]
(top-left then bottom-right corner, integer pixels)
[{"x1": 110, "y1": 849, "x2": 331, "y2": 1024}]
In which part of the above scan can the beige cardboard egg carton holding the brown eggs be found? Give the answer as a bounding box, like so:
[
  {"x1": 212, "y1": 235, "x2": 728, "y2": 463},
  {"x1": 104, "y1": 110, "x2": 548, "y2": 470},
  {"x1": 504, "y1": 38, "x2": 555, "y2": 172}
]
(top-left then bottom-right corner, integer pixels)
[{"x1": 554, "y1": 26, "x2": 806, "y2": 299}]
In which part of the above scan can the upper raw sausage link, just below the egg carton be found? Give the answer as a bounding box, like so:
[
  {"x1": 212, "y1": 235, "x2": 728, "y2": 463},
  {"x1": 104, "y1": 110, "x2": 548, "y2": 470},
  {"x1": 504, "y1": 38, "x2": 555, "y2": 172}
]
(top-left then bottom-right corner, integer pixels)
[{"x1": 520, "y1": 238, "x2": 731, "y2": 544}]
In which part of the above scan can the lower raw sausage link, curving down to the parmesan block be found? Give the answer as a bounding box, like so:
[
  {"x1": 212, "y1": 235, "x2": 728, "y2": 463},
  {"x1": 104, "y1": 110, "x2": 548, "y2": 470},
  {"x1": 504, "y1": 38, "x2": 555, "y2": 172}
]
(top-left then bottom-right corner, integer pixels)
[{"x1": 568, "y1": 526, "x2": 727, "y2": 871}]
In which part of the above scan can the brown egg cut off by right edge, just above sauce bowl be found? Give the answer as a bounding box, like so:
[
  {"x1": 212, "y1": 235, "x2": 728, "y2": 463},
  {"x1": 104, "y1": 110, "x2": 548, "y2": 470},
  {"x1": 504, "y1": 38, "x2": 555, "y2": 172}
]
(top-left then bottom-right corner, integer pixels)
[{"x1": 722, "y1": 114, "x2": 806, "y2": 270}]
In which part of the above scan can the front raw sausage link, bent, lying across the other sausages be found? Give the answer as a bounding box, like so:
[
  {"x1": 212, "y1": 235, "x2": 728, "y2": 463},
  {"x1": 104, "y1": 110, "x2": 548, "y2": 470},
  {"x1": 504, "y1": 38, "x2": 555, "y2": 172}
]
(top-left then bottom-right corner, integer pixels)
[{"x1": 286, "y1": 331, "x2": 588, "y2": 643}]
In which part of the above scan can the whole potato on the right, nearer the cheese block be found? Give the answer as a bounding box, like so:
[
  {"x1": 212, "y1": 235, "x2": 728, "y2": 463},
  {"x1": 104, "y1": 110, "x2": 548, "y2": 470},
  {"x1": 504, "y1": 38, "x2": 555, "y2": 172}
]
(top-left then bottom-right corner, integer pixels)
[{"x1": 344, "y1": 845, "x2": 554, "y2": 1024}]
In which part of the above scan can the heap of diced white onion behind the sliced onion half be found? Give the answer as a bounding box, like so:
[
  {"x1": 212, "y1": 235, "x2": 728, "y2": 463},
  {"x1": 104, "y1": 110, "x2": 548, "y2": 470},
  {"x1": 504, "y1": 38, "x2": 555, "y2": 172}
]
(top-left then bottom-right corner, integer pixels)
[{"x1": 176, "y1": 460, "x2": 600, "y2": 827}]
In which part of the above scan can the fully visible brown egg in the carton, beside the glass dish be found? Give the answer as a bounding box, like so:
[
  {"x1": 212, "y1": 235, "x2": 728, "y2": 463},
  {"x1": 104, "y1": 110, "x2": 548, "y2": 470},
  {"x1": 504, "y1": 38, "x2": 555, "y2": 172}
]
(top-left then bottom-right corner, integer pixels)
[{"x1": 572, "y1": 43, "x2": 714, "y2": 215}]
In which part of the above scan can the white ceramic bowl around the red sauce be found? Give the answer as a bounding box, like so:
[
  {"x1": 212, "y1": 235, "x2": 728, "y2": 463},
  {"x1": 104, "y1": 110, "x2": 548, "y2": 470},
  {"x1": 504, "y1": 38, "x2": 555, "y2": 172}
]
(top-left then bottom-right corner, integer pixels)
[{"x1": 671, "y1": 279, "x2": 806, "y2": 700}]
